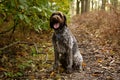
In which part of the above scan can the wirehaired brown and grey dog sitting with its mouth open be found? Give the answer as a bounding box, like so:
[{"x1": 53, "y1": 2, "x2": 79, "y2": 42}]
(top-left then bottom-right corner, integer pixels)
[{"x1": 50, "y1": 12, "x2": 83, "y2": 73}]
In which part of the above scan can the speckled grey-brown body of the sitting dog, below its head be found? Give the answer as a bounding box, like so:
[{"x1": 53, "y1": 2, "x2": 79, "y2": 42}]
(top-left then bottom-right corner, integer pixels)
[{"x1": 52, "y1": 26, "x2": 83, "y2": 69}]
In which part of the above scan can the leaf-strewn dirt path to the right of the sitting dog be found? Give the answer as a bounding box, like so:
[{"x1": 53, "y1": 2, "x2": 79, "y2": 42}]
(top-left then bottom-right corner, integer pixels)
[{"x1": 61, "y1": 22, "x2": 120, "y2": 80}]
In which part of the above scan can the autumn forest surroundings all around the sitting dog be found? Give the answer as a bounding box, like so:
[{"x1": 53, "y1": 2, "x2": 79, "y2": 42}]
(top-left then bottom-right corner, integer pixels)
[{"x1": 0, "y1": 0, "x2": 120, "y2": 80}]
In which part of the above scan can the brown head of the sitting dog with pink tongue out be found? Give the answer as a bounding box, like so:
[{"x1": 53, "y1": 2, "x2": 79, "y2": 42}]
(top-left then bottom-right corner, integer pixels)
[{"x1": 50, "y1": 12, "x2": 66, "y2": 30}]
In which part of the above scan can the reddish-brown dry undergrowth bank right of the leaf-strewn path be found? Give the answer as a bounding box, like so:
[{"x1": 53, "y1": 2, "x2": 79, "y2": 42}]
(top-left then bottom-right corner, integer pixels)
[{"x1": 72, "y1": 10, "x2": 120, "y2": 55}]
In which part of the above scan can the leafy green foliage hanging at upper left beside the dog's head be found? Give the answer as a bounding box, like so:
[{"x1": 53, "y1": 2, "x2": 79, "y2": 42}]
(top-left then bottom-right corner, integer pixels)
[{"x1": 0, "y1": 0, "x2": 70, "y2": 32}]
